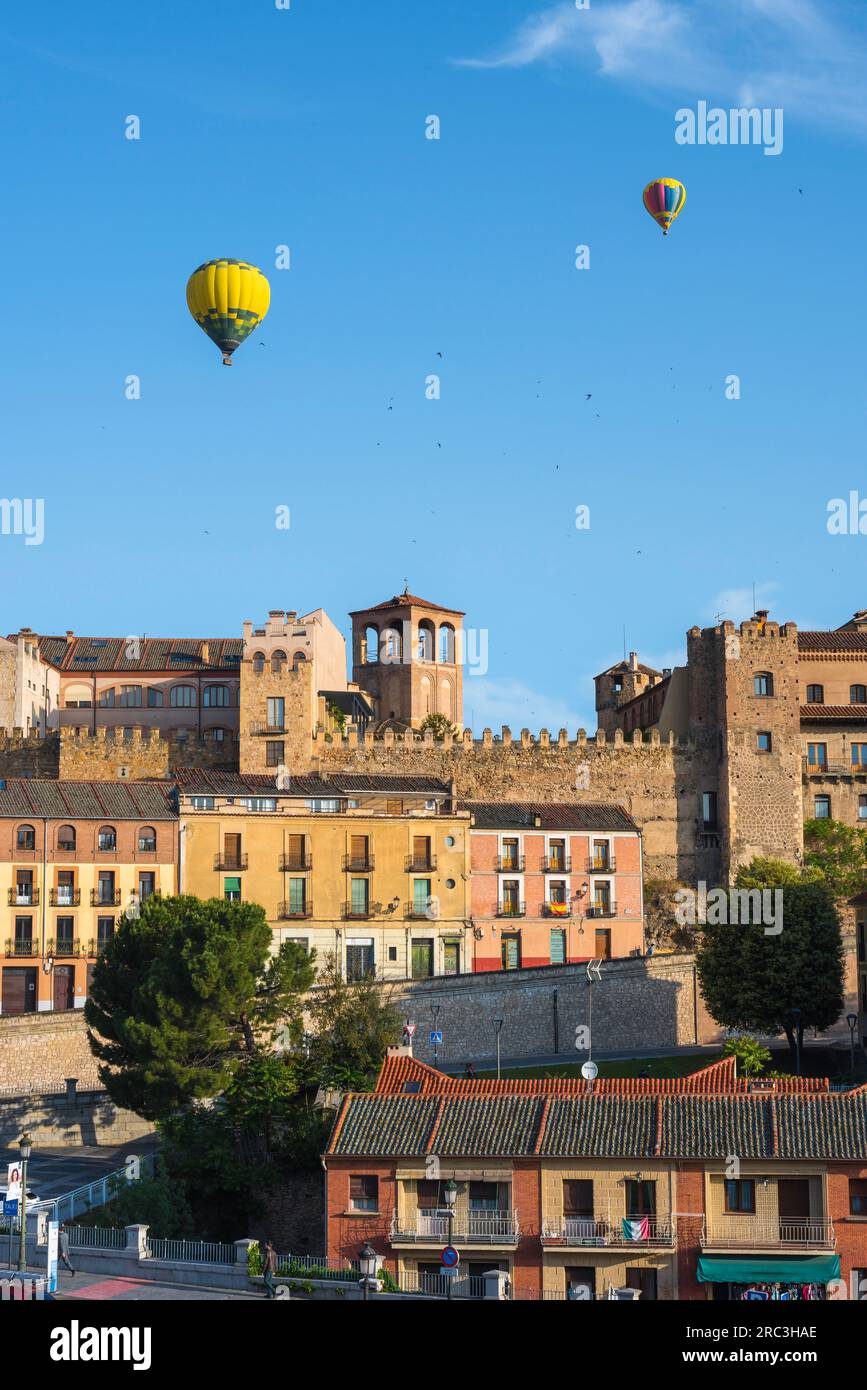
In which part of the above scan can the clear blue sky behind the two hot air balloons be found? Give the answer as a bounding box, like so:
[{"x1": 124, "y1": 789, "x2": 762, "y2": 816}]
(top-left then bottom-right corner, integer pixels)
[{"x1": 0, "y1": 0, "x2": 867, "y2": 731}]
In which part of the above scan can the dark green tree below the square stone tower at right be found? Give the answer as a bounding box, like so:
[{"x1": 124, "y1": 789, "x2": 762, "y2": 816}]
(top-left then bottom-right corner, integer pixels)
[{"x1": 696, "y1": 883, "x2": 843, "y2": 1054}]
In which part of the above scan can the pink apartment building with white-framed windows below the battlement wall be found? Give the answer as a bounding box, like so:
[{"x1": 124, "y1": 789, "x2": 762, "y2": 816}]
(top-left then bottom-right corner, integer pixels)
[{"x1": 460, "y1": 801, "x2": 643, "y2": 970}]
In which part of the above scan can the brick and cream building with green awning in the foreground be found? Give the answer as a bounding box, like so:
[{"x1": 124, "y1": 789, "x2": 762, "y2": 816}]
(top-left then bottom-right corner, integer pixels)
[{"x1": 324, "y1": 1048, "x2": 867, "y2": 1301}]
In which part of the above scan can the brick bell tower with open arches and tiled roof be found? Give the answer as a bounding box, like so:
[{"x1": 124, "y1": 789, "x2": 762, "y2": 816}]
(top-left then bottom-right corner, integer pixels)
[{"x1": 350, "y1": 588, "x2": 464, "y2": 728}]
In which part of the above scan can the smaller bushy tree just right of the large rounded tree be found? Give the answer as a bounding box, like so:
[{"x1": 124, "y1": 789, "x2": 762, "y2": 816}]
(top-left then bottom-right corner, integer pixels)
[{"x1": 308, "y1": 955, "x2": 403, "y2": 1091}]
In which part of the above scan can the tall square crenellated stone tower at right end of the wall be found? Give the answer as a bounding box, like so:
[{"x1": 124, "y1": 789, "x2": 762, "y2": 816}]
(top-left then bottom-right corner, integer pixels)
[{"x1": 686, "y1": 610, "x2": 803, "y2": 877}]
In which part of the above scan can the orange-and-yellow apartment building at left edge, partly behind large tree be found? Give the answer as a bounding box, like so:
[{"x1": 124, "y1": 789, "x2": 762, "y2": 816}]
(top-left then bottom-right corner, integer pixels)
[{"x1": 0, "y1": 778, "x2": 178, "y2": 1013}]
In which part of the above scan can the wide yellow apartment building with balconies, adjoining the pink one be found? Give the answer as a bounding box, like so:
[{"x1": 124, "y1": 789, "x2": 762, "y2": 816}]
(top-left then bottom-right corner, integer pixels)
[{"x1": 178, "y1": 770, "x2": 471, "y2": 980}]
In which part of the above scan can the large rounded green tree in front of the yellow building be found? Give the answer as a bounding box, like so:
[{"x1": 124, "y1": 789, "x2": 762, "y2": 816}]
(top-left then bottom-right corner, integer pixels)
[{"x1": 85, "y1": 897, "x2": 314, "y2": 1120}]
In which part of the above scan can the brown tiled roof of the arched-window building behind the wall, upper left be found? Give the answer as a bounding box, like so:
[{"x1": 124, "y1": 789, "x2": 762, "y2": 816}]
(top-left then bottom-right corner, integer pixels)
[{"x1": 39, "y1": 637, "x2": 243, "y2": 674}]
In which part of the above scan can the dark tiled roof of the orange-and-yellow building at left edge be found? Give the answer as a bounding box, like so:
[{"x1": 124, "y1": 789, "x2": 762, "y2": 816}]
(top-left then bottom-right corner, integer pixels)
[{"x1": 0, "y1": 777, "x2": 176, "y2": 820}]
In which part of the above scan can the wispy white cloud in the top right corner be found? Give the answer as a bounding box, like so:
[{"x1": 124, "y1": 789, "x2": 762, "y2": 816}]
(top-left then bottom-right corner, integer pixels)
[{"x1": 457, "y1": 0, "x2": 867, "y2": 131}]
